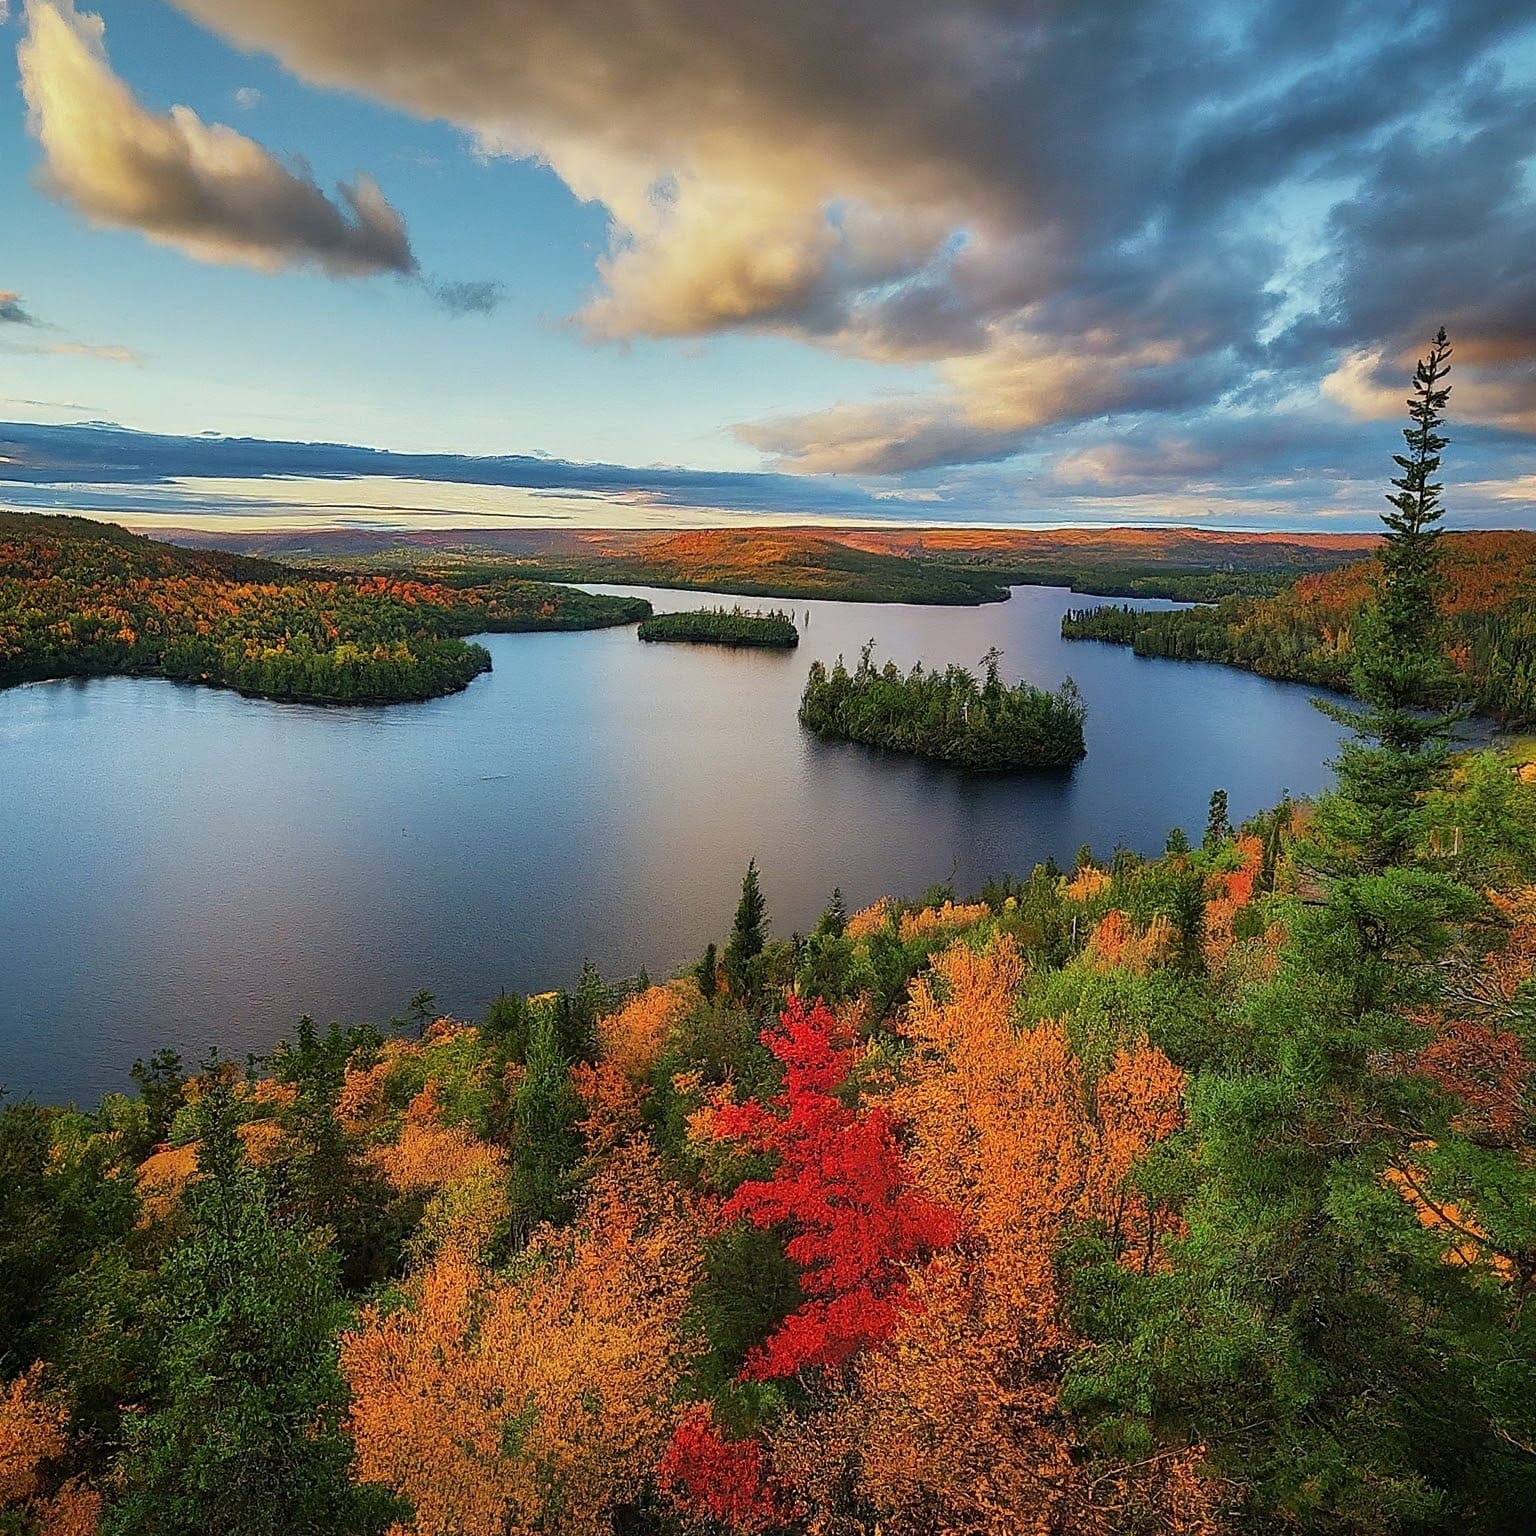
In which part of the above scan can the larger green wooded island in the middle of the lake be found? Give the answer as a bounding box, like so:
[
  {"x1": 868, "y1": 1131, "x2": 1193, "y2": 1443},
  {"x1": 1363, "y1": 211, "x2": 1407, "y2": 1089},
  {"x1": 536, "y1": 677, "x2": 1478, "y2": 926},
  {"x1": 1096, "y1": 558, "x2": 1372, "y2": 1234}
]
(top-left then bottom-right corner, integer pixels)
[{"x1": 800, "y1": 641, "x2": 1087, "y2": 773}]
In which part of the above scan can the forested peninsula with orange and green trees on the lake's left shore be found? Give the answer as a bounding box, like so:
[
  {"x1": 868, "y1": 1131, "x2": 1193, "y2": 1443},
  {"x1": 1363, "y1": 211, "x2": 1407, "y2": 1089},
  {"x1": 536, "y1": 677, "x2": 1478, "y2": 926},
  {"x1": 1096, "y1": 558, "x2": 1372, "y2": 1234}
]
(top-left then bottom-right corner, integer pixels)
[{"x1": 0, "y1": 511, "x2": 651, "y2": 703}]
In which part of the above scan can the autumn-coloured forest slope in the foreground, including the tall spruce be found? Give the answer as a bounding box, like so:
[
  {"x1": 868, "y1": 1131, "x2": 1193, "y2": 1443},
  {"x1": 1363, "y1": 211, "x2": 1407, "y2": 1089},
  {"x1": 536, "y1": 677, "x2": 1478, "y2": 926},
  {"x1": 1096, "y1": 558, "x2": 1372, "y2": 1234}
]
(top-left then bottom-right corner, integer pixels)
[{"x1": 0, "y1": 332, "x2": 1536, "y2": 1536}]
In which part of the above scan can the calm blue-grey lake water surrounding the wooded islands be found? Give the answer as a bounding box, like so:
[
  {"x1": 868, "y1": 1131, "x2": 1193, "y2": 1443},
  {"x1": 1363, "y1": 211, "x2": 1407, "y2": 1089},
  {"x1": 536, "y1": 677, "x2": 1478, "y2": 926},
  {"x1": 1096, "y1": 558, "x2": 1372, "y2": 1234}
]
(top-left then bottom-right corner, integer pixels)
[{"x1": 0, "y1": 587, "x2": 1338, "y2": 1103}]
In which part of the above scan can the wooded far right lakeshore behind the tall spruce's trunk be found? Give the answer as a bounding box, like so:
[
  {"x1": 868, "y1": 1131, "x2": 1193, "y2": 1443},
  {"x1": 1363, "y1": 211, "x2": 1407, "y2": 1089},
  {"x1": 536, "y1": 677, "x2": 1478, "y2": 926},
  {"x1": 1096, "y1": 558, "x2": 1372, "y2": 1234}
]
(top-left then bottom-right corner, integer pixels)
[{"x1": 1061, "y1": 533, "x2": 1536, "y2": 730}]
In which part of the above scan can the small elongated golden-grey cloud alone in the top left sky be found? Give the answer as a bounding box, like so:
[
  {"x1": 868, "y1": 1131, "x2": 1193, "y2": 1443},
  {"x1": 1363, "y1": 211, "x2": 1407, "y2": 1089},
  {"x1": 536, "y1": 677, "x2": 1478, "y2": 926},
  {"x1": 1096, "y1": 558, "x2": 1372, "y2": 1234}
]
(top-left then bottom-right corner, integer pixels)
[{"x1": 17, "y1": 0, "x2": 416, "y2": 276}]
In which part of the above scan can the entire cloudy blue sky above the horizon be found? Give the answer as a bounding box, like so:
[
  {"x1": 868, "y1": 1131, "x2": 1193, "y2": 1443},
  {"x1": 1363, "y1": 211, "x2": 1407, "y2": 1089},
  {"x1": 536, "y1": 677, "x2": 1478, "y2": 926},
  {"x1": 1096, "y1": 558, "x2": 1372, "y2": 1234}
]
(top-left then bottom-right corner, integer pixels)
[{"x1": 0, "y1": 0, "x2": 1536, "y2": 531}]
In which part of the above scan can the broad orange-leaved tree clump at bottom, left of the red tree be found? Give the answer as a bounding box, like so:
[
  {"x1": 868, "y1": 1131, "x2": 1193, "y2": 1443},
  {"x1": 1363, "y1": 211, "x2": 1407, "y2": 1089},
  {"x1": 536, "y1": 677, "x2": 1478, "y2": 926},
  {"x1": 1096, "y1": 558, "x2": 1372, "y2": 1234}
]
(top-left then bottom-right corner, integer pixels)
[{"x1": 341, "y1": 1150, "x2": 702, "y2": 1536}]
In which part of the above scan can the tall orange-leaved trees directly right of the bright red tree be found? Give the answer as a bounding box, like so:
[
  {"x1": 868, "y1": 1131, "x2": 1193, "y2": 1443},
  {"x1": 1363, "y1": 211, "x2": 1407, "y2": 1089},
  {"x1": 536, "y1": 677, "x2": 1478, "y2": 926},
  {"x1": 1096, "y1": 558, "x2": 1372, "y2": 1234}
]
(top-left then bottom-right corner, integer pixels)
[{"x1": 761, "y1": 938, "x2": 1210, "y2": 1536}]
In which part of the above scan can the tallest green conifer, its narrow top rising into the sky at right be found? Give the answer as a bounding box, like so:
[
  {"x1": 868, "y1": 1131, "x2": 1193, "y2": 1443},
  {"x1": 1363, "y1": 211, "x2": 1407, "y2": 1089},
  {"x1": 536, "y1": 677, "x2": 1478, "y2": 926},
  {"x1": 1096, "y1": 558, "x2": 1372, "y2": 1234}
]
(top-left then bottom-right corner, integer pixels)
[{"x1": 1074, "y1": 332, "x2": 1536, "y2": 1536}]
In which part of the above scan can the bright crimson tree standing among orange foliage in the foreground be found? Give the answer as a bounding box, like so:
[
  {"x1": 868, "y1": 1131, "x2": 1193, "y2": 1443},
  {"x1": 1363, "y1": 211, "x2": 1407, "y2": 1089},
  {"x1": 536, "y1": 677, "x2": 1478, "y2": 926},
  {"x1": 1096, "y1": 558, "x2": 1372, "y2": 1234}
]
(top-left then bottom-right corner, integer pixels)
[{"x1": 713, "y1": 998, "x2": 958, "y2": 1381}]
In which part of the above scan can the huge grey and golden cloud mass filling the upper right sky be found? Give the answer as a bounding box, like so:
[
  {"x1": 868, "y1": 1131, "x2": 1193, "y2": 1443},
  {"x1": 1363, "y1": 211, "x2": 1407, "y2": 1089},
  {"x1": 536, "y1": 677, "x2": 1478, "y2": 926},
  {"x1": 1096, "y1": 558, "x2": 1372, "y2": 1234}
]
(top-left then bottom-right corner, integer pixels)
[{"x1": 158, "y1": 0, "x2": 1536, "y2": 475}]
